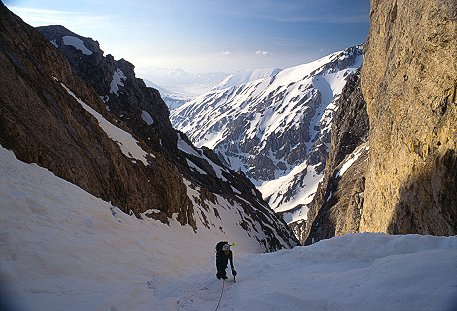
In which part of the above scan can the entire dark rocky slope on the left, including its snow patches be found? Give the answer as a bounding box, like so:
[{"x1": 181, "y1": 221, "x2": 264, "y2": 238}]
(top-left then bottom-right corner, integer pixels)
[{"x1": 0, "y1": 4, "x2": 296, "y2": 251}]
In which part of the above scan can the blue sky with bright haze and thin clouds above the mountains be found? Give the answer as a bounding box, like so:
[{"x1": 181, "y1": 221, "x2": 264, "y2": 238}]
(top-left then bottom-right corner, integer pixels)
[{"x1": 4, "y1": 0, "x2": 369, "y2": 72}]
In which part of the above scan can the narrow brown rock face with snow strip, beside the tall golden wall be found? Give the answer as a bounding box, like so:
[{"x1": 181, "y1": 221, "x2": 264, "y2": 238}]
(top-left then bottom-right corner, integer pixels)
[{"x1": 302, "y1": 72, "x2": 369, "y2": 244}]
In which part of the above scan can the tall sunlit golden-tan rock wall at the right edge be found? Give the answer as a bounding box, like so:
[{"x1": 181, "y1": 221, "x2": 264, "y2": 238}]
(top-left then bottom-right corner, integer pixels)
[{"x1": 360, "y1": 0, "x2": 457, "y2": 235}]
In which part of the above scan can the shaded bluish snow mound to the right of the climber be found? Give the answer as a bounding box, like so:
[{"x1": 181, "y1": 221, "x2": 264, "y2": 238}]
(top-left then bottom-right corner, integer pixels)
[{"x1": 222, "y1": 233, "x2": 457, "y2": 311}]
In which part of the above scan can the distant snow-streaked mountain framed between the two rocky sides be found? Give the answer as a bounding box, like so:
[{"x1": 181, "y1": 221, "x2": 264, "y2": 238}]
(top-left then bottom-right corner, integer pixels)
[{"x1": 170, "y1": 46, "x2": 362, "y2": 222}]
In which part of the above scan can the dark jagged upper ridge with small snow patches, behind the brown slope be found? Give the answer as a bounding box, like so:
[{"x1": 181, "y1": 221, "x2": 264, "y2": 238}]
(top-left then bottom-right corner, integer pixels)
[{"x1": 37, "y1": 25, "x2": 178, "y2": 157}]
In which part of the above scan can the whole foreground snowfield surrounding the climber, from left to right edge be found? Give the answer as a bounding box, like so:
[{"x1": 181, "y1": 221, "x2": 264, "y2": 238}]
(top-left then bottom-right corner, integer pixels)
[{"x1": 0, "y1": 148, "x2": 457, "y2": 311}]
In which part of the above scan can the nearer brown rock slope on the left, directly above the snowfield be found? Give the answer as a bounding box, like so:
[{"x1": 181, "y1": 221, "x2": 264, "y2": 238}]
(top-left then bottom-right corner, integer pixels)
[{"x1": 0, "y1": 5, "x2": 195, "y2": 227}]
